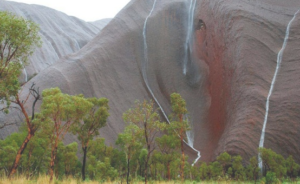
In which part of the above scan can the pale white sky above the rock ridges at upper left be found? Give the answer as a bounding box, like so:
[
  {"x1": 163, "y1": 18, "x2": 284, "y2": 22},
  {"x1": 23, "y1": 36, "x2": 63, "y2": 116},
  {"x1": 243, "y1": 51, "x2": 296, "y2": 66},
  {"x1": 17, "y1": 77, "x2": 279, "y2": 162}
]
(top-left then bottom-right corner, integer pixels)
[{"x1": 7, "y1": 0, "x2": 130, "y2": 22}]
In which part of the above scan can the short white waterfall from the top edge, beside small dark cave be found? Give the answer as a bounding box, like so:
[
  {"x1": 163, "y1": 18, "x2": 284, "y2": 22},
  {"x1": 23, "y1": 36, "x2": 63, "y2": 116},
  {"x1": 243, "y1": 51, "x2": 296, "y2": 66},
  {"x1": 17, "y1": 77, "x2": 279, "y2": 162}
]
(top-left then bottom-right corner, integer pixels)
[{"x1": 183, "y1": 0, "x2": 197, "y2": 75}]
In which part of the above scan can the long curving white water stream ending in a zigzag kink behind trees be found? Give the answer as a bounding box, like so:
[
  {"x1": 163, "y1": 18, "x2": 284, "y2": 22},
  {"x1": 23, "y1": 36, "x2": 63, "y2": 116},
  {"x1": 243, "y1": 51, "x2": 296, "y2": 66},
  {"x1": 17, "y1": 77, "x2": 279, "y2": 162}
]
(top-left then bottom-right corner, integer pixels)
[{"x1": 141, "y1": 0, "x2": 201, "y2": 165}]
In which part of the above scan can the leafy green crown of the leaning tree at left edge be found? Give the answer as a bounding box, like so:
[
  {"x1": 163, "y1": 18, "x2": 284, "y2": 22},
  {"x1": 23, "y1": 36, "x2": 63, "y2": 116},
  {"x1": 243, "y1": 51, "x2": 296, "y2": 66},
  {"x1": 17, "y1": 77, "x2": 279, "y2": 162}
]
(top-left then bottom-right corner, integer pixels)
[{"x1": 0, "y1": 11, "x2": 41, "y2": 113}]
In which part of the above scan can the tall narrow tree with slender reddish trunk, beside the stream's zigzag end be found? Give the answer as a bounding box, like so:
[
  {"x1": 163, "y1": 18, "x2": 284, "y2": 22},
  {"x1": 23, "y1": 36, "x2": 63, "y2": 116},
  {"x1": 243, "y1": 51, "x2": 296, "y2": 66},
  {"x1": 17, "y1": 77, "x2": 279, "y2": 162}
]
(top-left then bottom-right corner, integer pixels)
[{"x1": 171, "y1": 93, "x2": 189, "y2": 181}]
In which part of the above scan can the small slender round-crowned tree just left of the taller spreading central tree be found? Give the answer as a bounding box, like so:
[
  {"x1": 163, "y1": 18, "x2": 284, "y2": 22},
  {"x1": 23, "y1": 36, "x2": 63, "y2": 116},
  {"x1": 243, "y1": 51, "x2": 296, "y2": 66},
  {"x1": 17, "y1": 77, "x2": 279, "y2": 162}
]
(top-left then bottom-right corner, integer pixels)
[{"x1": 116, "y1": 124, "x2": 143, "y2": 184}]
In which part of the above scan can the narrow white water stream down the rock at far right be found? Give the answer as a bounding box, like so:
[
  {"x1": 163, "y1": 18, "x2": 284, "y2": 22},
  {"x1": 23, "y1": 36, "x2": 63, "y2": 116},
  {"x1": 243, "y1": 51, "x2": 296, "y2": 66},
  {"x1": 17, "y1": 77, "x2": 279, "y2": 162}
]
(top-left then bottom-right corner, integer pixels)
[{"x1": 258, "y1": 10, "x2": 299, "y2": 170}]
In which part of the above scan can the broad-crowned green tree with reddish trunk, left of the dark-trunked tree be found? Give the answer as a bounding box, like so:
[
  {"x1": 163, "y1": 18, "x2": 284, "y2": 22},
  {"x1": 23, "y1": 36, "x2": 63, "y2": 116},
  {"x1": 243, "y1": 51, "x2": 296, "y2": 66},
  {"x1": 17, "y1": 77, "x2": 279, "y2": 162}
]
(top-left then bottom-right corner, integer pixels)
[{"x1": 37, "y1": 88, "x2": 93, "y2": 181}]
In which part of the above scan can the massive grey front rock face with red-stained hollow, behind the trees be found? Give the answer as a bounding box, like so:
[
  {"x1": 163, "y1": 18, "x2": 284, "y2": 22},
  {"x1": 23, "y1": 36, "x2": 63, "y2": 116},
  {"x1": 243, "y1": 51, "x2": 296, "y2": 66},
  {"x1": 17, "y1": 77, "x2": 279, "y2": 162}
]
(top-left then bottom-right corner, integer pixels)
[{"x1": 0, "y1": 0, "x2": 300, "y2": 161}]
